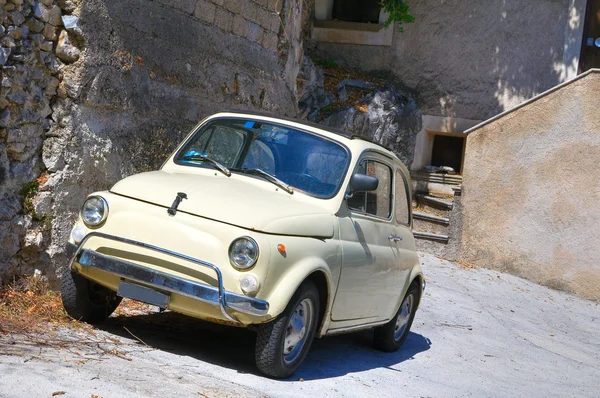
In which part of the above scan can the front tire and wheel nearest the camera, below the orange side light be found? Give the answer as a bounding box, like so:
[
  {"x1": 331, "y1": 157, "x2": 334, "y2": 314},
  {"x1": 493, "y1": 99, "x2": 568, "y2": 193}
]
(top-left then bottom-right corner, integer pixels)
[{"x1": 255, "y1": 281, "x2": 320, "y2": 379}]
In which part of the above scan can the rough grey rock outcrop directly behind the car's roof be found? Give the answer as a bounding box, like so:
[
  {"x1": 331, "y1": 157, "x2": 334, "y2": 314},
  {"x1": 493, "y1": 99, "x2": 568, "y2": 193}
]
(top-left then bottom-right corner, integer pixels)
[{"x1": 320, "y1": 86, "x2": 423, "y2": 166}]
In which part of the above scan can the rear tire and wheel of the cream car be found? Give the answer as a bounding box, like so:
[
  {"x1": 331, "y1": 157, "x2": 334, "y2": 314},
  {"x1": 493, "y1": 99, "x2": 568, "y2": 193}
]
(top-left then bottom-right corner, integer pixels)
[{"x1": 373, "y1": 284, "x2": 419, "y2": 352}]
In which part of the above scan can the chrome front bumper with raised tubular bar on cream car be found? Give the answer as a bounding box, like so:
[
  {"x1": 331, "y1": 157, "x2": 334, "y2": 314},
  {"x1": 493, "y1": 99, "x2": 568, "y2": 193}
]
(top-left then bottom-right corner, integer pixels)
[{"x1": 67, "y1": 232, "x2": 269, "y2": 323}]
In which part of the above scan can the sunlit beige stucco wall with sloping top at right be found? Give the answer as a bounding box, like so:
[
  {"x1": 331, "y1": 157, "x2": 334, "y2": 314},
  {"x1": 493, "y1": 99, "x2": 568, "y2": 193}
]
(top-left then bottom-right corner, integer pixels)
[{"x1": 460, "y1": 70, "x2": 600, "y2": 300}]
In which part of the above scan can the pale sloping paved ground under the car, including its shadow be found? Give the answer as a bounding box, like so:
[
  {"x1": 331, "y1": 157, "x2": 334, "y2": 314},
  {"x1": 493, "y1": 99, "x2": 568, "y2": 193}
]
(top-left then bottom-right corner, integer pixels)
[{"x1": 0, "y1": 254, "x2": 600, "y2": 398}]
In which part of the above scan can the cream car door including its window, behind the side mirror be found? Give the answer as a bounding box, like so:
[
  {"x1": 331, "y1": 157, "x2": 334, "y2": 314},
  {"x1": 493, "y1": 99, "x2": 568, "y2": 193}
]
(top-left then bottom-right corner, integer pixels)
[{"x1": 332, "y1": 152, "x2": 398, "y2": 322}]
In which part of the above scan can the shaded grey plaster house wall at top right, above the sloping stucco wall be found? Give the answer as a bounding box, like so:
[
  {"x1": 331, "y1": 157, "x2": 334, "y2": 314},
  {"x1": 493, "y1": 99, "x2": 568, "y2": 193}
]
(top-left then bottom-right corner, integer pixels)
[{"x1": 311, "y1": 0, "x2": 586, "y2": 120}]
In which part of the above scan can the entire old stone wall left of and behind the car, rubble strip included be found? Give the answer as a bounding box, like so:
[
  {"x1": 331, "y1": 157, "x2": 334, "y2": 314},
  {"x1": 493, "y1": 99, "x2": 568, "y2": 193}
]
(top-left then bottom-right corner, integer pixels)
[{"x1": 0, "y1": 0, "x2": 301, "y2": 279}]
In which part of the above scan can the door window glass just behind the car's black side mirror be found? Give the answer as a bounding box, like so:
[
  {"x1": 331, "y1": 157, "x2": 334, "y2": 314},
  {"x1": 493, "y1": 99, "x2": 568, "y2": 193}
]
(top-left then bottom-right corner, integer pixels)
[{"x1": 348, "y1": 160, "x2": 392, "y2": 218}]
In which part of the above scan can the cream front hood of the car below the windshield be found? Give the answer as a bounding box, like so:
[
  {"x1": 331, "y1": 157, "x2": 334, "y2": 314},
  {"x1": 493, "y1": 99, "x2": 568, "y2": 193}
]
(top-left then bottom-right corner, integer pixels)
[{"x1": 110, "y1": 171, "x2": 334, "y2": 238}]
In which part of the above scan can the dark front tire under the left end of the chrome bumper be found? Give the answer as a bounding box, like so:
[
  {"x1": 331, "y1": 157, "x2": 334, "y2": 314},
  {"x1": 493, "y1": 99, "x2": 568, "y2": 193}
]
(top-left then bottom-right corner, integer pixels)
[{"x1": 60, "y1": 270, "x2": 121, "y2": 323}]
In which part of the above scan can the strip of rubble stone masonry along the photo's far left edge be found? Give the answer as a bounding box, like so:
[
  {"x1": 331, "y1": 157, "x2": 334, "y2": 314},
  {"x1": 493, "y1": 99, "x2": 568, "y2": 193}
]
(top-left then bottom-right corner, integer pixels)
[{"x1": 0, "y1": 0, "x2": 67, "y2": 278}]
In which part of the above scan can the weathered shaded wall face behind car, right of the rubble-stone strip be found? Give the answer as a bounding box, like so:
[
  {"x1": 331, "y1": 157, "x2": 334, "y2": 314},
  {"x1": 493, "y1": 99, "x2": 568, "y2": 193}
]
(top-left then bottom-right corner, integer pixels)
[{"x1": 0, "y1": 0, "x2": 298, "y2": 278}]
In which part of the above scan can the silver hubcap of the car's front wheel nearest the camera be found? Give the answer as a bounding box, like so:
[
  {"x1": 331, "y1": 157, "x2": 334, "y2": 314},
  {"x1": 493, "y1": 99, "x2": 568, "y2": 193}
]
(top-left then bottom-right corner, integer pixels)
[{"x1": 283, "y1": 299, "x2": 314, "y2": 364}]
